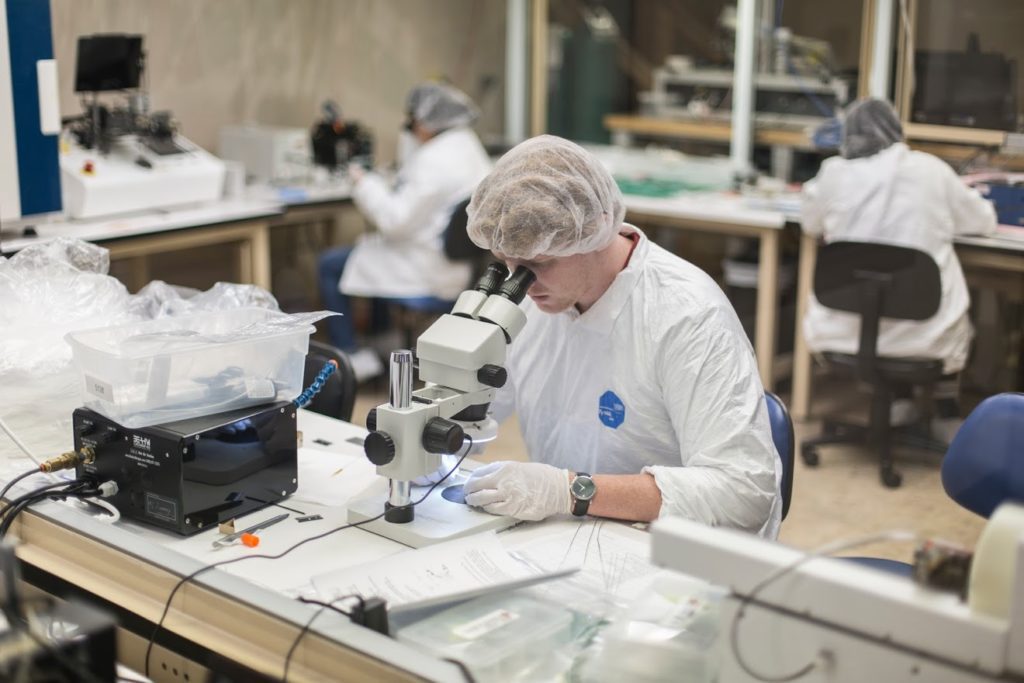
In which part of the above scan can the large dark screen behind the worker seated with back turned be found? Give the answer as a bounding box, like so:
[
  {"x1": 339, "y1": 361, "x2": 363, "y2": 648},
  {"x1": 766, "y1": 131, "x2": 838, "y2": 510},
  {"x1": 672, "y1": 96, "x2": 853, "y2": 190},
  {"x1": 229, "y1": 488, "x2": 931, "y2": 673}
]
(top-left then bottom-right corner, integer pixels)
[{"x1": 910, "y1": 39, "x2": 1017, "y2": 131}]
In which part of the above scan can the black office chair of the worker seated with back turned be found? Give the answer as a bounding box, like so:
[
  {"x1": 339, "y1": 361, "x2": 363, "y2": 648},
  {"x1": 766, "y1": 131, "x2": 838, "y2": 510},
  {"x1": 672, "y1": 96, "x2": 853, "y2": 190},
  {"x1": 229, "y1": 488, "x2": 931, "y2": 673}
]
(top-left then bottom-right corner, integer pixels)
[{"x1": 800, "y1": 242, "x2": 946, "y2": 487}]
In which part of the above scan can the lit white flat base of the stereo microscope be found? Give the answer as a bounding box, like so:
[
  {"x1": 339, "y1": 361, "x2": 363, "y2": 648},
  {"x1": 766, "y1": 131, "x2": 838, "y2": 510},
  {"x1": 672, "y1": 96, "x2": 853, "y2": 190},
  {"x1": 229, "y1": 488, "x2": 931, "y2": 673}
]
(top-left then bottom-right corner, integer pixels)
[{"x1": 348, "y1": 475, "x2": 518, "y2": 548}]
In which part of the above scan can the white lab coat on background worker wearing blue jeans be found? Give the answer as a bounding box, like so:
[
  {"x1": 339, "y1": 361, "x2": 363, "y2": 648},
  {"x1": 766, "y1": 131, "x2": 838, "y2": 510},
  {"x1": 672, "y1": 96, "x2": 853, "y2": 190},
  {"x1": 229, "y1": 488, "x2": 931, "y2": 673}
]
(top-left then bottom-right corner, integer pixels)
[{"x1": 339, "y1": 127, "x2": 490, "y2": 299}]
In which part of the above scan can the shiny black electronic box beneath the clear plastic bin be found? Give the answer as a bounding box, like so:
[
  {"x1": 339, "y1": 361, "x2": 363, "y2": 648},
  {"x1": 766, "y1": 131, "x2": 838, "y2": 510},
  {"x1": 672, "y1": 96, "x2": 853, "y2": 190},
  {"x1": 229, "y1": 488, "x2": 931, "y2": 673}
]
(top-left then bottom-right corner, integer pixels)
[{"x1": 73, "y1": 401, "x2": 298, "y2": 535}]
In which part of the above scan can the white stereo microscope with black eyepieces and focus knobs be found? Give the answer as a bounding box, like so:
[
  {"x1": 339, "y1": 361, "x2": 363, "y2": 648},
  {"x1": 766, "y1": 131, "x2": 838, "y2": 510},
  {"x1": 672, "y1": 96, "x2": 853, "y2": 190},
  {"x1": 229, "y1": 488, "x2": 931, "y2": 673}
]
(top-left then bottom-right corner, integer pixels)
[{"x1": 348, "y1": 263, "x2": 535, "y2": 548}]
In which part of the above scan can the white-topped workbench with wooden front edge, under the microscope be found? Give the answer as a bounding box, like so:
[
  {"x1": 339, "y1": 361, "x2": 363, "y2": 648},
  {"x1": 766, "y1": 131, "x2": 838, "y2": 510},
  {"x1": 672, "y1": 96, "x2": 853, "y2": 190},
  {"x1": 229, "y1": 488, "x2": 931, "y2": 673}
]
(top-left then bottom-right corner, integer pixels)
[{"x1": 0, "y1": 411, "x2": 653, "y2": 681}]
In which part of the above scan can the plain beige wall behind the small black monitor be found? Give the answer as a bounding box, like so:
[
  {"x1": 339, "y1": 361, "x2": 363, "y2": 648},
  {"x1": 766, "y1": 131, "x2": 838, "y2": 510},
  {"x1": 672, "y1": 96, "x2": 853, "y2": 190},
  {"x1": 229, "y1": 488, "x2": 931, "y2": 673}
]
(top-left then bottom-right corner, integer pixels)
[{"x1": 51, "y1": 0, "x2": 505, "y2": 162}]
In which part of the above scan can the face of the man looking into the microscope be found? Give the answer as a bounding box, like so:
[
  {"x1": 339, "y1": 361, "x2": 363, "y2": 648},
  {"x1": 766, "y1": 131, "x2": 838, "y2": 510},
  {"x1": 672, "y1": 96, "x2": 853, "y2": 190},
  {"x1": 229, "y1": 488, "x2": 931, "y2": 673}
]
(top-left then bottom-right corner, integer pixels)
[{"x1": 495, "y1": 252, "x2": 600, "y2": 313}]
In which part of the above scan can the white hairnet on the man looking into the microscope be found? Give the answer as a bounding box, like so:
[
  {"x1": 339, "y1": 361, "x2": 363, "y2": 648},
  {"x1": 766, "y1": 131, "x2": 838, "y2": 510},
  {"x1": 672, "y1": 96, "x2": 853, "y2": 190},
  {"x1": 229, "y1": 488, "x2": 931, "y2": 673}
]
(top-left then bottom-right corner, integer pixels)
[{"x1": 466, "y1": 135, "x2": 626, "y2": 260}]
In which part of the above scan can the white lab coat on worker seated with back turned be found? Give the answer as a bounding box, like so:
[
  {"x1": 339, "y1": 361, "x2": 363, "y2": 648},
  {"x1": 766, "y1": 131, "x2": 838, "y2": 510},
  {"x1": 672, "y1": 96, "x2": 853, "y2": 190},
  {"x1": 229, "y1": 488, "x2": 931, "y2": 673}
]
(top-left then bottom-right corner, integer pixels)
[{"x1": 801, "y1": 142, "x2": 995, "y2": 374}]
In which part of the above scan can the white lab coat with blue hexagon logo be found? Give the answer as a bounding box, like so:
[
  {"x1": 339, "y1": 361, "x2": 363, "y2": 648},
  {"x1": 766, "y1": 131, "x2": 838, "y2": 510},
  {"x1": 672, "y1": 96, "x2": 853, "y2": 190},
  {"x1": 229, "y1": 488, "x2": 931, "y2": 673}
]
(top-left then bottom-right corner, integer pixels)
[{"x1": 492, "y1": 225, "x2": 781, "y2": 539}]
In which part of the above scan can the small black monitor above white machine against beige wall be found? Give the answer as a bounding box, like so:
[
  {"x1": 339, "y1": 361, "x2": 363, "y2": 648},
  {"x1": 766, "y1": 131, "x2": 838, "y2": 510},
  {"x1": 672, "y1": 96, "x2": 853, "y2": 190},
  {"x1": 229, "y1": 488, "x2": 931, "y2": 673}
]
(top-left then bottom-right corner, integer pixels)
[{"x1": 75, "y1": 34, "x2": 142, "y2": 92}]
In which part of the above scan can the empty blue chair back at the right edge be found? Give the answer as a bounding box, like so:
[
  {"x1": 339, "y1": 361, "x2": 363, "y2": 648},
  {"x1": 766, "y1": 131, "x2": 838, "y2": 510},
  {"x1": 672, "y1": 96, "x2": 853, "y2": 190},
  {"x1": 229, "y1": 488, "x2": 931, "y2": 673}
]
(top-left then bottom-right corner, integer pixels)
[{"x1": 942, "y1": 393, "x2": 1024, "y2": 517}]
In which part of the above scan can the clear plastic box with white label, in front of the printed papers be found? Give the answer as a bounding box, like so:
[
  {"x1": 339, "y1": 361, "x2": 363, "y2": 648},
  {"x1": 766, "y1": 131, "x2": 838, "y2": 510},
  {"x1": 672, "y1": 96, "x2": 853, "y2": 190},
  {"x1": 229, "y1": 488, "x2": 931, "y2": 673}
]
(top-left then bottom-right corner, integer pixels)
[{"x1": 397, "y1": 593, "x2": 573, "y2": 682}]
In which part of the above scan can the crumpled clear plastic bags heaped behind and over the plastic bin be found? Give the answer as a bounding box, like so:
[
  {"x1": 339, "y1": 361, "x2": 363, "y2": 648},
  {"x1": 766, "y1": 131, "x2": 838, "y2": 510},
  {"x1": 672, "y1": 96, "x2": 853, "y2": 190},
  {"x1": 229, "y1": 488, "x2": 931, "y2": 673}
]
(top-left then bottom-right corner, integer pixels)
[{"x1": 0, "y1": 238, "x2": 330, "y2": 458}]
